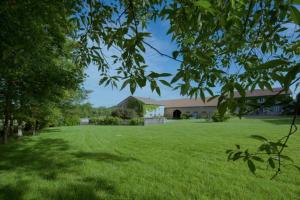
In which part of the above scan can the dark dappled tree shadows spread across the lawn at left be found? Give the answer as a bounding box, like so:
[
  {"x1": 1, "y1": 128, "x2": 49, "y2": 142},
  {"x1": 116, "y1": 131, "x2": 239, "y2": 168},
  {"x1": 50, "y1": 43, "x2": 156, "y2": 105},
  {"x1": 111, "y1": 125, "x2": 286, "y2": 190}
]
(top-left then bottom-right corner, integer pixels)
[{"x1": 0, "y1": 136, "x2": 139, "y2": 200}]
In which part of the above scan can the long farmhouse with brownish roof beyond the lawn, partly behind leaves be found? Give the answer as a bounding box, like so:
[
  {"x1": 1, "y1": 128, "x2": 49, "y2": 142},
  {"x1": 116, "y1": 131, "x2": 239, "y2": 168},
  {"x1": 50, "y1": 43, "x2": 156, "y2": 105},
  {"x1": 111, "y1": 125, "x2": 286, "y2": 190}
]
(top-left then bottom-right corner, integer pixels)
[{"x1": 118, "y1": 88, "x2": 291, "y2": 119}]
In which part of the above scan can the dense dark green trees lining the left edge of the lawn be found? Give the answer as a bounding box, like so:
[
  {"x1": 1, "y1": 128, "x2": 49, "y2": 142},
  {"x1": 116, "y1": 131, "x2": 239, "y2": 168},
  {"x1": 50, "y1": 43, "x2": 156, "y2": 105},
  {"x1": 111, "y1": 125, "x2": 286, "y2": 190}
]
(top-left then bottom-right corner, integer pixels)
[{"x1": 0, "y1": 0, "x2": 84, "y2": 143}]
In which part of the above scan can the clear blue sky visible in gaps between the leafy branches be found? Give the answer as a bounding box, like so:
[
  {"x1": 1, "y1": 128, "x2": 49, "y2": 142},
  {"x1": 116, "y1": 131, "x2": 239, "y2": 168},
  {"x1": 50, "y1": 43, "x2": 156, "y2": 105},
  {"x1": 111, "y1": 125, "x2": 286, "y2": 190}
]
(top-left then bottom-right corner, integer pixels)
[{"x1": 84, "y1": 21, "x2": 299, "y2": 107}]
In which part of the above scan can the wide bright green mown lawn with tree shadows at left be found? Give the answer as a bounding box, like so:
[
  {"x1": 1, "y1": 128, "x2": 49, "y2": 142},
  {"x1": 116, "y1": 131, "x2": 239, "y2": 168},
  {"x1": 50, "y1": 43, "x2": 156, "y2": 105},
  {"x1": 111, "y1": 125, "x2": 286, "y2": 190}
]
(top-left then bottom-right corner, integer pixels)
[{"x1": 0, "y1": 118, "x2": 300, "y2": 200}]
